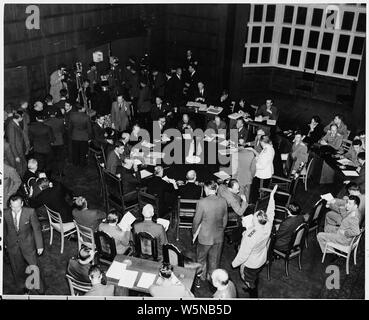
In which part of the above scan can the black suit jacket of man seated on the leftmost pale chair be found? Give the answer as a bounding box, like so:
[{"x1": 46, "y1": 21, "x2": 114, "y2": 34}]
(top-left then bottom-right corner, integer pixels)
[{"x1": 35, "y1": 184, "x2": 73, "y2": 223}]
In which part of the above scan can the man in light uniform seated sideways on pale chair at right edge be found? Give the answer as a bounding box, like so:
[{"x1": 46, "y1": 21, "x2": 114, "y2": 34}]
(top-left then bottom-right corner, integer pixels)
[{"x1": 317, "y1": 196, "x2": 360, "y2": 252}]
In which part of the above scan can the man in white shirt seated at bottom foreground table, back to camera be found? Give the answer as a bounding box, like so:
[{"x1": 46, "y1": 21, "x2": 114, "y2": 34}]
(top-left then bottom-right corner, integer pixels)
[{"x1": 149, "y1": 264, "x2": 194, "y2": 298}]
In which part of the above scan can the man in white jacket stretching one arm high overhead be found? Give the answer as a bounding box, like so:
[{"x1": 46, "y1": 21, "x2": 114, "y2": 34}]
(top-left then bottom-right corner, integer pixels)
[{"x1": 232, "y1": 185, "x2": 278, "y2": 298}]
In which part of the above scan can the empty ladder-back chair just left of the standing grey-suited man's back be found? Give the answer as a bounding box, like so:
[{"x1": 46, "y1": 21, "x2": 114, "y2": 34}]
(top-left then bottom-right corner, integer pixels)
[{"x1": 174, "y1": 196, "x2": 198, "y2": 241}]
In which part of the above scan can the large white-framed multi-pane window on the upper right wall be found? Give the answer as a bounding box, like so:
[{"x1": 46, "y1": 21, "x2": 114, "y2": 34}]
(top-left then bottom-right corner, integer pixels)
[{"x1": 243, "y1": 4, "x2": 366, "y2": 80}]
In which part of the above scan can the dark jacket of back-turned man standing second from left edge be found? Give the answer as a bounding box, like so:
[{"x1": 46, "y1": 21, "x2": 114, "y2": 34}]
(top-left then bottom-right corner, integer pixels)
[{"x1": 28, "y1": 122, "x2": 55, "y2": 153}]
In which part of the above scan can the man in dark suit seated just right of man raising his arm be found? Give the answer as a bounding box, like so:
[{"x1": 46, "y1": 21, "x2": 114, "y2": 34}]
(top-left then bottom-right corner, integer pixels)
[{"x1": 274, "y1": 202, "x2": 309, "y2": 252}]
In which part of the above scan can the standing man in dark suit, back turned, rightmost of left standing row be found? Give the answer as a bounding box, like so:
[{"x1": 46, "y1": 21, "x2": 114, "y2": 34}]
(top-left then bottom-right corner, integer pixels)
[{"x1": 69, "y1": 105, "x2": 92, "y2": 167}]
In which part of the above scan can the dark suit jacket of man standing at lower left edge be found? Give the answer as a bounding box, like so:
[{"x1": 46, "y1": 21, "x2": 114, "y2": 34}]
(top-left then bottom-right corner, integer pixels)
[{"x1": 4, "y1": 207, "x2": 44, "y2": 265}]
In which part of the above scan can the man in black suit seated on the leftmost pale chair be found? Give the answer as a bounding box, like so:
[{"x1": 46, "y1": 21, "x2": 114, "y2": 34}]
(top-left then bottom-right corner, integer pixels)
[{"x1": 34, "y1": 178, "x2": 73, "y2": 223}]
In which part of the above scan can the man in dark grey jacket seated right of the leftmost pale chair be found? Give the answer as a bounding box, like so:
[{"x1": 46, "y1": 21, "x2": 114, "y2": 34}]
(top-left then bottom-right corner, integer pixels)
[{"x1": 72, "y1": 197, "x2": 106, "y2": 231}]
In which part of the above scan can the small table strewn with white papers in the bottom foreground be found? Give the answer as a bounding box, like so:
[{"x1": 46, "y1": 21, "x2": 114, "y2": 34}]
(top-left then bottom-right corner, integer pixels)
[{"x1": 106, "y1": 255, "x2": 196, "y2": 293}]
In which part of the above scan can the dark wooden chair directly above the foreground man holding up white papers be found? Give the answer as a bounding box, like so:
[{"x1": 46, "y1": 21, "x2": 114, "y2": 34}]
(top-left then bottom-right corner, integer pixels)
[{"x1": 102, "y1": 169, "x2": 138, "y2": 212}]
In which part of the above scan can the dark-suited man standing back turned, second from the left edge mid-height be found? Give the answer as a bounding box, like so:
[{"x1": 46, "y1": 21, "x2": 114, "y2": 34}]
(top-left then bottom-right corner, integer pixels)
[{"x1": 29, "y1": 116, "x2": 55, "y2": 173}]
